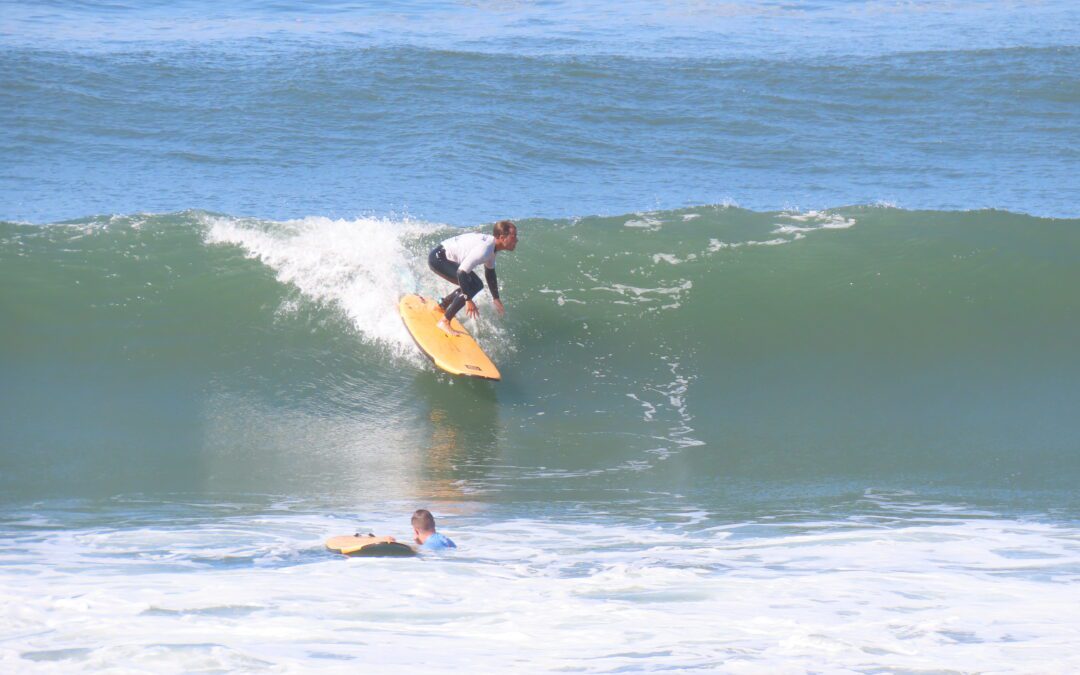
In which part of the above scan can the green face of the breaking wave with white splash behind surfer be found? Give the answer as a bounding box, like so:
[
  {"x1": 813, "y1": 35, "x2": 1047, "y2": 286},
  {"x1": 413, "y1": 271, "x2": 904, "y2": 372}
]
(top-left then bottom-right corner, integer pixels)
[{"x1": 0, "y1": 206, "x2": 1080, "y2": 501}]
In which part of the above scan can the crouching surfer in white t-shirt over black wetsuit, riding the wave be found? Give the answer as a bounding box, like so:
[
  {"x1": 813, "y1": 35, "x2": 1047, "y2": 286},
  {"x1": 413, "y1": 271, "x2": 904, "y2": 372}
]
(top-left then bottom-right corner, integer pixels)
[{"x1": 428, "y1": 220, "x2": 517, "y2": 335}]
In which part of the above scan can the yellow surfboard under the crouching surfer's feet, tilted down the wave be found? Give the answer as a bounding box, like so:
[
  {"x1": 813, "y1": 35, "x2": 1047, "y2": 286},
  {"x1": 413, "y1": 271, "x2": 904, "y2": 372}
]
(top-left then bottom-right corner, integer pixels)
[{"x1": 397, "y1": 295, "x2": 501, "y2": 380}]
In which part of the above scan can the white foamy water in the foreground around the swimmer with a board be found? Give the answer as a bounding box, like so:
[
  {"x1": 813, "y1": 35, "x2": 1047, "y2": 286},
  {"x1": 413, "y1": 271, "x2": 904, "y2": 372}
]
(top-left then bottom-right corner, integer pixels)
[{"x1": 0, "y1": 504, "x2": 1080, "y2": 673}]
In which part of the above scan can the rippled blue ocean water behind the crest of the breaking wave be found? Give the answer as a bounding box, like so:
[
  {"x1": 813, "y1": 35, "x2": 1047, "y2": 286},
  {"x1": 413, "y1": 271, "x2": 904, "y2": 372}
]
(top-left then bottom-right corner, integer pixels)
[{"x1": 0, "y1": 2, "x2": 1080, "y2": 225}]
